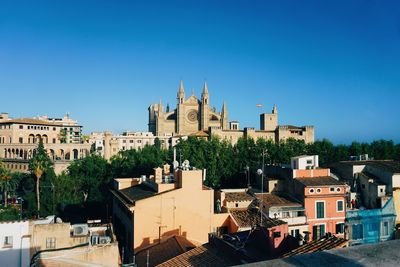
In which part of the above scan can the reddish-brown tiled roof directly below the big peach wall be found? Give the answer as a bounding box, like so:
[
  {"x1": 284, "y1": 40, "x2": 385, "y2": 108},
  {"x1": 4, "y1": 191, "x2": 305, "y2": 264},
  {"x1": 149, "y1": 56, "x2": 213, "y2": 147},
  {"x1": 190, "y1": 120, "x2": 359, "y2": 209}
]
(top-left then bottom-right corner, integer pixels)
[{"x1": 135, "y1": 236, "x2": 196, "y2": 266}]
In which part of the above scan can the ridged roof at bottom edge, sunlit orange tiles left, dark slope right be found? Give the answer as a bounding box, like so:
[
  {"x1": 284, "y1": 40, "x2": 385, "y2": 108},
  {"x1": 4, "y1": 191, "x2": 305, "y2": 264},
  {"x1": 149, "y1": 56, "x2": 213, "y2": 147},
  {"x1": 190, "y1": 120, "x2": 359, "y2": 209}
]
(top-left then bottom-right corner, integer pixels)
[{"x1": 157, "y1": 244, "x2": 237, "y2": 267}]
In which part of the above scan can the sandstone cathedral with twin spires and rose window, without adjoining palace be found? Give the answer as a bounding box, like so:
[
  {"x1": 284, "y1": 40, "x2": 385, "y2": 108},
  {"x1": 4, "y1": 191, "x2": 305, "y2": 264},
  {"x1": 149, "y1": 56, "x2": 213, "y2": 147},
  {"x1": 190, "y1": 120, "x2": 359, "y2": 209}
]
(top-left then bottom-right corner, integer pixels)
[{"x1": 149, "y1": 81, "x2": 228, "y2": 136}]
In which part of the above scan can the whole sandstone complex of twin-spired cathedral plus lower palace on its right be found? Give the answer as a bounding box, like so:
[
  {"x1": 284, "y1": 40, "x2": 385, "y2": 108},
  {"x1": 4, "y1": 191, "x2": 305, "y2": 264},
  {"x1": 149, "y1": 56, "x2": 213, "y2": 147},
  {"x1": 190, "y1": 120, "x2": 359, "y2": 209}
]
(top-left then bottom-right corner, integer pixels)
[{"x1": 149, "y1": 81, "x2": 314, "y2": 144}]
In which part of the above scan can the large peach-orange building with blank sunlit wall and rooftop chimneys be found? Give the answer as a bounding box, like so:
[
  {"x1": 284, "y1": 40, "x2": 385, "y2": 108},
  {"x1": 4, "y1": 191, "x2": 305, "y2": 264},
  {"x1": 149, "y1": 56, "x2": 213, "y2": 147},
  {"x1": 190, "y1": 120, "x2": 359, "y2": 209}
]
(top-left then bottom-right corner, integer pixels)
[{"x1": 112, "y1": 165, "x2": 229, "y2": 262}]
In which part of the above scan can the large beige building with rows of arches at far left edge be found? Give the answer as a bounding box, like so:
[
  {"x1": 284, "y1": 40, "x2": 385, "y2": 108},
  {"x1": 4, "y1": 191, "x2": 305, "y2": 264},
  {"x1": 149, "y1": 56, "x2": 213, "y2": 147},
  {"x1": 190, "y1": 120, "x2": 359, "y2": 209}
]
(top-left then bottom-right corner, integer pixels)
[{"x1": 0, "y1": 113, "x2": 90, "y2": 173}]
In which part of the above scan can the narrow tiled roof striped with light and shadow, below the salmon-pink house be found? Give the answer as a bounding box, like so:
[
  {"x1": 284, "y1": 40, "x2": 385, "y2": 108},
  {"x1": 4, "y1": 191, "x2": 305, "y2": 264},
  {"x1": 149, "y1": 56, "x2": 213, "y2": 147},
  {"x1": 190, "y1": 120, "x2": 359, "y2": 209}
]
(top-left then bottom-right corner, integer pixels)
[{"x1": 282, "y1": 236, "x2": 349, "y2": 258}]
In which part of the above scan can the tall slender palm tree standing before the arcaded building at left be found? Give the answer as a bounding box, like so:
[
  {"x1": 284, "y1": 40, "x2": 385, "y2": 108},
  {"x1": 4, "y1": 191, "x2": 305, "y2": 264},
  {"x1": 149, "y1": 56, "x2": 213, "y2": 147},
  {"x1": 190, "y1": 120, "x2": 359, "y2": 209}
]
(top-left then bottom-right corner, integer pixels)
[{"x1": 29, "y1": 139, "x2": 52, "y2": 216}]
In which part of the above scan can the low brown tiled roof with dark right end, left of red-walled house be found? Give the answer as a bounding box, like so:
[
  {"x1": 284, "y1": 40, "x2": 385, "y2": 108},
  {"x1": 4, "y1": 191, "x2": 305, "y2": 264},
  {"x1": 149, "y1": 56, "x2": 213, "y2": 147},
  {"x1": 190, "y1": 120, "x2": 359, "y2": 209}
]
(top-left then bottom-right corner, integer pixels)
[{"x1": 229, "y1": 208, "x2": 286, "y2": 228}]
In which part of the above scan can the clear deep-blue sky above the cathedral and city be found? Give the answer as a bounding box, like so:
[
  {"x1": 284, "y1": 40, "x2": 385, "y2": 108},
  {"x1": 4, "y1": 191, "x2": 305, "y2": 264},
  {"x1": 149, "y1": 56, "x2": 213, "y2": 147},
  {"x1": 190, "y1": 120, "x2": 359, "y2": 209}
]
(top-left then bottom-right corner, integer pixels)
[{"x1": 0, "y1": 0, "x2": 400, "y2": 143}]
